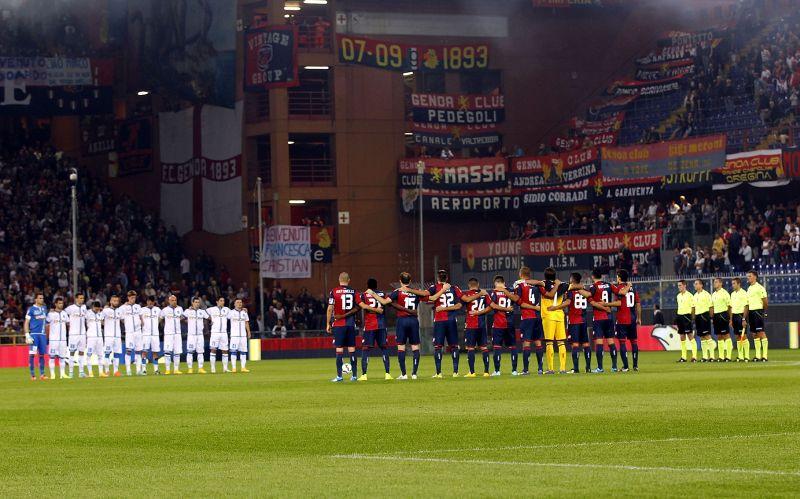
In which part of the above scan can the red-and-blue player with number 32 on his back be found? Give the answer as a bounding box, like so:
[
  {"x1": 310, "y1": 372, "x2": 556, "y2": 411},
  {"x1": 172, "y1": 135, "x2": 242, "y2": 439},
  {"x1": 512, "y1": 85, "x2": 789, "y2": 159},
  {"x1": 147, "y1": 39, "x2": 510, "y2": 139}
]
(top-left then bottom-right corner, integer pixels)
[{"x1": 428, "y1": 270, "x2": 461, "y2": 378}]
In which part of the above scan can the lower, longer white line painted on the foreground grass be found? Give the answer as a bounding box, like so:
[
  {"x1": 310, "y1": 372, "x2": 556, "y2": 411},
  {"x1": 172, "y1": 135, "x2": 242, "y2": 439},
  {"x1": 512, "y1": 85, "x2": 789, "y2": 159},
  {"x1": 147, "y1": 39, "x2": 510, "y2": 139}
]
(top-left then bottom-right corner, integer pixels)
[{"x1": 331, "y1": 454, "x2": 800, "y2": 477}]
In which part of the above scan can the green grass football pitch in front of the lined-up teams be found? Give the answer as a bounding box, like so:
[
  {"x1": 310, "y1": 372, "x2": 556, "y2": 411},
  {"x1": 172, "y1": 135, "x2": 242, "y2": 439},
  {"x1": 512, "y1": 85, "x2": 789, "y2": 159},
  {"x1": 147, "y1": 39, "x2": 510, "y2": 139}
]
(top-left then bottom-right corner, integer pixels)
[{"x1": 0, "y1": 350, "x2": 800, "y2": 497}]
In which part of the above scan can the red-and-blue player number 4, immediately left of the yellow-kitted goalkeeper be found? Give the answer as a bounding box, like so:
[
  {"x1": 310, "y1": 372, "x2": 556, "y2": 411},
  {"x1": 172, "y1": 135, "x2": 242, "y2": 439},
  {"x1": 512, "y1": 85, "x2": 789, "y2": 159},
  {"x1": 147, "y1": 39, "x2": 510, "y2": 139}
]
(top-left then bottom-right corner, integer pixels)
[{"x1": 511, "y1": 267, "x2": 544, "y2": 376}]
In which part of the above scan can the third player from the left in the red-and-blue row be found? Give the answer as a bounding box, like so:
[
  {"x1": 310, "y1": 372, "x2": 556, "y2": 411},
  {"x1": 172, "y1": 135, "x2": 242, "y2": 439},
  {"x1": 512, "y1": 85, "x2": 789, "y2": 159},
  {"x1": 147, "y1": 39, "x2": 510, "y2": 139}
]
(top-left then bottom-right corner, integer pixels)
[{"x1": 389, "y1": 272, "x2": 428, "y2": 380}]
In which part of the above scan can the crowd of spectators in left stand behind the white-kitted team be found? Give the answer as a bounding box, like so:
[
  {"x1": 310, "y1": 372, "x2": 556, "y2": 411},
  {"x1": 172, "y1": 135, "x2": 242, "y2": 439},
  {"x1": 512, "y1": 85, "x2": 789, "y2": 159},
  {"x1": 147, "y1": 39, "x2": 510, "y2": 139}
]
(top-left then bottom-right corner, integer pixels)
[{"x1": 0, "y1": 146, "x2": 323, "y2": 338}]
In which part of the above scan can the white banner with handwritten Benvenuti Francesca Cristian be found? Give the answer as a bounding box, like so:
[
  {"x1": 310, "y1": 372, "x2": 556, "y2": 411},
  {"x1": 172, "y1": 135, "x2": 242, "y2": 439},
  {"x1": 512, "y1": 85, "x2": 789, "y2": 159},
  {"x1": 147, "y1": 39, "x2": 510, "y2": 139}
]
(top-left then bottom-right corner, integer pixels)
[{"x1": 261, "y1": 225, "x2": 311, "y2": 279}]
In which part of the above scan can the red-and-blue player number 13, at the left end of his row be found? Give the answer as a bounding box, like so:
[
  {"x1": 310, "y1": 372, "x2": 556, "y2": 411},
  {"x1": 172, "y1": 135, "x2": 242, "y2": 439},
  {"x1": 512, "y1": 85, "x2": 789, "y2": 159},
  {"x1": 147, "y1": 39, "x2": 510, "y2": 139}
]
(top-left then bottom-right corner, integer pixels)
[{"x1": 326, "y1": 272, "x2": 361, "y2": 382}]
